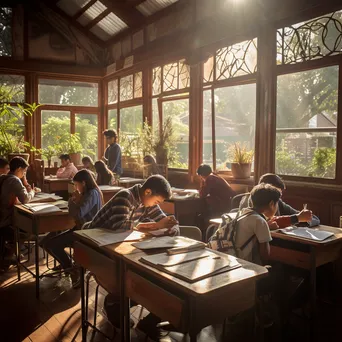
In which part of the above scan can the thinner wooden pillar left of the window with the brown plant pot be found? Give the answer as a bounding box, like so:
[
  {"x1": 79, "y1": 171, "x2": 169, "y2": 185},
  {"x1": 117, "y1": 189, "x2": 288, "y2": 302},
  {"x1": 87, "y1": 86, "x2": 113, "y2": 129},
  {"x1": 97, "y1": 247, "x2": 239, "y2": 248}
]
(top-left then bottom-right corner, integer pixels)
[{"x1": 189, "y1": 63, "x2": 203, "y2": 182}]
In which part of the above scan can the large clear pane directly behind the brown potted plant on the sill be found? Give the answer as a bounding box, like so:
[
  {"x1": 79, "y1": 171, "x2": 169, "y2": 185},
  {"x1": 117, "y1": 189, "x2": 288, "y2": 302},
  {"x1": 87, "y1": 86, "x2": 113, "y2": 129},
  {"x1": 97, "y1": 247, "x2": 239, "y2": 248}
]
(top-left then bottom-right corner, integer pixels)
[{"x1": 215, "y1": 84, "x2": 256, "y2": 170}]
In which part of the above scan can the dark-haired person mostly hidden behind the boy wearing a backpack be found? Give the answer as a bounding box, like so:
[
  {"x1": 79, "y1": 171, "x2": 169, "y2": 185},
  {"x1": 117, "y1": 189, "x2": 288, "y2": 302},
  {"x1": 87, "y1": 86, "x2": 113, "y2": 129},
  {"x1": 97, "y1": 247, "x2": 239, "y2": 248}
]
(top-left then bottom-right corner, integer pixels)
[{"x1": 240, "y1": 173, "x2": 320, "y2": 229}]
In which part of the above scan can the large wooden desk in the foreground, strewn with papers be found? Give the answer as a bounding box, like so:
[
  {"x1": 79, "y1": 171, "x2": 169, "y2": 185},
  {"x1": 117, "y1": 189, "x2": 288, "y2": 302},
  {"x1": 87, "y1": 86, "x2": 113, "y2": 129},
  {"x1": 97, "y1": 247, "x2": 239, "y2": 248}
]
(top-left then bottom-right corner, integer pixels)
[{"x1": 74, "y1": 233, "x2": 267, "y2": 342}]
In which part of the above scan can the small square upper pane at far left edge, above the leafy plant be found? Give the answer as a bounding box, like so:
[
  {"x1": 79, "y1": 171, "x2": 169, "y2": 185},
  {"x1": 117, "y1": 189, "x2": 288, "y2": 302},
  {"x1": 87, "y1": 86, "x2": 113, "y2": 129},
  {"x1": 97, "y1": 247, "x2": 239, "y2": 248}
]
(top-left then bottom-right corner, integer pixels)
[{"x1": 0, "y1": 74, "x2": 25, "y2": 102}]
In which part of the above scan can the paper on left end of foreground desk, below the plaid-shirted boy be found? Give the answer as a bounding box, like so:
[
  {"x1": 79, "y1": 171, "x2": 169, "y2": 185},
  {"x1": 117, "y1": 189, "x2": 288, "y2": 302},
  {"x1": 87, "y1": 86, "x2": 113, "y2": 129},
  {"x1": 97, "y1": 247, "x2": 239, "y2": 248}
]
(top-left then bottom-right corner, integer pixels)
[{"x1": 78, "y1": 228, "x2": 145, "y2": 247}]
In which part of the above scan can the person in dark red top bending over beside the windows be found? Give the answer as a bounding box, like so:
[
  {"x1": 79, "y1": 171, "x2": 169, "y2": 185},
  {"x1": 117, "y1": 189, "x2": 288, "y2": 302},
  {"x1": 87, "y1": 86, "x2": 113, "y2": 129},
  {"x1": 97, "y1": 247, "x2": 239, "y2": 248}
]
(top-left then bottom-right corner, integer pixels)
[{"x1": 197, "y1": 164, "x2": 235, "y2": 218}]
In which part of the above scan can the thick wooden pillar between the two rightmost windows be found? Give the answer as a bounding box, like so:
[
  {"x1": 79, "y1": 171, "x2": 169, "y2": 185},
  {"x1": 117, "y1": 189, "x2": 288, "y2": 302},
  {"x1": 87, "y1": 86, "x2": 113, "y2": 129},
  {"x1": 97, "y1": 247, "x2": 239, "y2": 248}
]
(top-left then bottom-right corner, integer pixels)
[{"x1": 254, "y1": 25, "x2": 277, "y2": 182}]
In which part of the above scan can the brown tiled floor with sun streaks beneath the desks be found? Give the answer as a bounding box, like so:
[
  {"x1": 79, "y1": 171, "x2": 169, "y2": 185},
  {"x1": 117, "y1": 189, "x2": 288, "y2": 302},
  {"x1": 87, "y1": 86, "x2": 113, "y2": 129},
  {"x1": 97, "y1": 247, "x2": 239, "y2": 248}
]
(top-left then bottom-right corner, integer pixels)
[{"x1": 0, "y1": 247, "x2": 342, "y2": 342}]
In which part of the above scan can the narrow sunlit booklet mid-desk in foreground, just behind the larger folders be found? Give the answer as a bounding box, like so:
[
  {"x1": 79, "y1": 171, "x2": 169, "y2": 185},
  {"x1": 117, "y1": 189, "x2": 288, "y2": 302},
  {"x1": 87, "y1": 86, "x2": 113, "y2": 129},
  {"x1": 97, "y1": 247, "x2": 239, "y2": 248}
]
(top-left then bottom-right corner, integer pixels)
[{"x1": 133, "y1": 236, "x2": 205, "y2": 250}]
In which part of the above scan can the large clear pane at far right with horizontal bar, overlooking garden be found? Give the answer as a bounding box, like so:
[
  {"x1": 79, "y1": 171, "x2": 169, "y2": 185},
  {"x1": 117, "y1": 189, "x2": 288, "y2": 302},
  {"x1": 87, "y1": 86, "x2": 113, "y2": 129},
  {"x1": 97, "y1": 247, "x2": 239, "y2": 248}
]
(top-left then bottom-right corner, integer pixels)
[{"x1": 276, "y1": 66, "x2": 339, "y2": 178}]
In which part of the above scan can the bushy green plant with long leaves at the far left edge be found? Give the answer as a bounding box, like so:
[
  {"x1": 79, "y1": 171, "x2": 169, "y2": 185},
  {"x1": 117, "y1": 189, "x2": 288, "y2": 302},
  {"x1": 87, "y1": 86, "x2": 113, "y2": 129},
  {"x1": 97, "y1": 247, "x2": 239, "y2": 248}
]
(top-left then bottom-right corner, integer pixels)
[{"x1": 0, "y1": 86, "x2": 39, "y2": 161}]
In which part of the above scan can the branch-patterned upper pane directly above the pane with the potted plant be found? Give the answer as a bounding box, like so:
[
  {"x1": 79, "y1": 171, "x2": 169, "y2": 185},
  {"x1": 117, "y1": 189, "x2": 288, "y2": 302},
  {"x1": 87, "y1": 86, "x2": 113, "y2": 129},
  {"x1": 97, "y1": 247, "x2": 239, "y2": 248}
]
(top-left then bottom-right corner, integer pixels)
[{"x1": 216, "y1": 38, "x2": 257, "y2": 80}]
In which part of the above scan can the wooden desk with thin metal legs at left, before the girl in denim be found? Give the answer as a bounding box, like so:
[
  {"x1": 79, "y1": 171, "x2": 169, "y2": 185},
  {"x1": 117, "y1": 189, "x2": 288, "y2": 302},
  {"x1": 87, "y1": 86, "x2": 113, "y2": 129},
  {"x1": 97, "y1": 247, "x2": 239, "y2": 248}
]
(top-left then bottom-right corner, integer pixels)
[{"x1": 14, "y1": 205, "x2": 75, "y2": 298}]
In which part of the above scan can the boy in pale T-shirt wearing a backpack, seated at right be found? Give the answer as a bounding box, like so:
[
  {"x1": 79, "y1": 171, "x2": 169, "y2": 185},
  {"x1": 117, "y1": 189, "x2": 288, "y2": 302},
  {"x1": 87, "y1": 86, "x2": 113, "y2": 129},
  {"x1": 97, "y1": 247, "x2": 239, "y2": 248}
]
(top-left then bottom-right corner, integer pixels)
[{"x1": 209, "y1": 183, "x2": 281, "y2": 265}]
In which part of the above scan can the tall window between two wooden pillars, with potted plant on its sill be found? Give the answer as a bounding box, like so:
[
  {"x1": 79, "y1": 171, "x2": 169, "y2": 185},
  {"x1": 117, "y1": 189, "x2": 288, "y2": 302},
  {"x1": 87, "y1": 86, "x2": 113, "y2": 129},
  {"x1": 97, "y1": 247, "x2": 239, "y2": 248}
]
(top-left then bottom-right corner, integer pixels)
[{"x1": 202, "y1": 38, "x2": 257, "y2": 171}]
